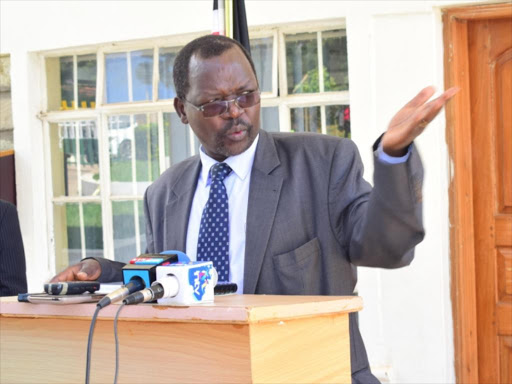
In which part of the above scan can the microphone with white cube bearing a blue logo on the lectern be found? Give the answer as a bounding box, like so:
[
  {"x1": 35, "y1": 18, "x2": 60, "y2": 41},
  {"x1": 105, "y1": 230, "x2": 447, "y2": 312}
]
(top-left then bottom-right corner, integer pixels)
[{"x1": 123, "y1": 261, "x2": 218, "y2": 305}]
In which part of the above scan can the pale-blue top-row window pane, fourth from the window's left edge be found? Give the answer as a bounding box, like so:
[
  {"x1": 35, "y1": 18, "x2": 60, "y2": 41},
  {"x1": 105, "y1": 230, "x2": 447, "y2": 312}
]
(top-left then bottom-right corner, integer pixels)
[{"x1": 130, "y1": 49, "x2": 153, "y2": 101}]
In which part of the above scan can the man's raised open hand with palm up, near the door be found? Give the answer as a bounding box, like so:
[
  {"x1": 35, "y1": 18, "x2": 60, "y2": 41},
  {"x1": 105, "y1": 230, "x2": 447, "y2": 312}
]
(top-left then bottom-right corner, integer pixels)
[{"x1": 381, "y1": 87, "x2": 460, "y2": 157}]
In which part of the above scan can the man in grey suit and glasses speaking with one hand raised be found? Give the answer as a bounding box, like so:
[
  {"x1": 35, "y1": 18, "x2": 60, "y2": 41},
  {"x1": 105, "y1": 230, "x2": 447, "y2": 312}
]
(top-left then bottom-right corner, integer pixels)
[{"x1": 52, "y1": 35, "x2": 456, "y2": 383}]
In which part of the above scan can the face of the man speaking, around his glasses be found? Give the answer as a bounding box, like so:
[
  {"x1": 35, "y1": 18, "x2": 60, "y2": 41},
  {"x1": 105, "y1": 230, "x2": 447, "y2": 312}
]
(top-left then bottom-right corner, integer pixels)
[{"x1": 174, "y1": 46, "x2": 260, "y2": 161}]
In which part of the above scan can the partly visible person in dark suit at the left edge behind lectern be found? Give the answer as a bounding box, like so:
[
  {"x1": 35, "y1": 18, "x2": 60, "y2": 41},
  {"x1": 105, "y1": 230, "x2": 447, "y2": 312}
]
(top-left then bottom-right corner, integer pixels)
[{"x1": 0, "y1": 200, "x2": 27, "y2": 296}]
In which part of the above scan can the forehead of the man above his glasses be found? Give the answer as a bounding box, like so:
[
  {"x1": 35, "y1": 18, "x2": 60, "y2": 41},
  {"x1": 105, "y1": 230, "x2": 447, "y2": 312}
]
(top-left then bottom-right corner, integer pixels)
[{"x1": 187, "y1": 46, "x2": 257, "y2": 98}]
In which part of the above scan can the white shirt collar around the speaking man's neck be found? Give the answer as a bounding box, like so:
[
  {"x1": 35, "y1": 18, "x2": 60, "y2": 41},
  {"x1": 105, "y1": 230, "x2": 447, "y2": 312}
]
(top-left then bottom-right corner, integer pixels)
[{"x1": 199, "y1": 133, "x2": 260, "y2": 186}]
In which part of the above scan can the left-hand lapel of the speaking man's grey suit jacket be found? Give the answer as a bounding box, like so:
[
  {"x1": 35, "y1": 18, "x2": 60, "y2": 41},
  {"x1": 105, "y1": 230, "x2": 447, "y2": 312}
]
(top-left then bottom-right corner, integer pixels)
[{"x1": 164, "y1": 156, "x2": 201, "y2": 252}]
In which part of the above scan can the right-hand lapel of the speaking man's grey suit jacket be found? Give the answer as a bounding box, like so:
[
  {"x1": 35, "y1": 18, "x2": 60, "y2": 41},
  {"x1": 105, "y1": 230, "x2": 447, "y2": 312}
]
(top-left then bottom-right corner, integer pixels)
[{"x1": 244, "y1": 130, "x2": 283, "y2": 294}]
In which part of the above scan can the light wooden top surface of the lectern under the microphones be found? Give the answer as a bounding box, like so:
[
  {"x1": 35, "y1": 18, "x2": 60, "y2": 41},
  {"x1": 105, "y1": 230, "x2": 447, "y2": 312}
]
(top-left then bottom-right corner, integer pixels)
[{"x1": 0, "y1": 295, "x2": 363, "y2": 323}]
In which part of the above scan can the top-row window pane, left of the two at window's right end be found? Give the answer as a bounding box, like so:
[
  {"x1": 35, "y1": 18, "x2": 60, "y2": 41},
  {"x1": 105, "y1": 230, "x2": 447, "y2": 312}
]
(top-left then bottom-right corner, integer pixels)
[{"x1": 285, "y1": 33, "x2": 320, "y2": 94}]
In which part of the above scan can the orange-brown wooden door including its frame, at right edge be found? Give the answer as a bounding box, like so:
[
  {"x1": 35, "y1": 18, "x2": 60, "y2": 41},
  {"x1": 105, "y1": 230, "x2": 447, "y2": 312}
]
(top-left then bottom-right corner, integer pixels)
[{"x1": 443, "y1": 2, "x2": 512, "y2": 384}]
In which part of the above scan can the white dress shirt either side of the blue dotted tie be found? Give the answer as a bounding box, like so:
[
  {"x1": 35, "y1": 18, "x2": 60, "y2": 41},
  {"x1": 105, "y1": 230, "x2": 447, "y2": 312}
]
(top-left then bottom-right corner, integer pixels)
[{"x1": 186, "y1": 135, "x2": 259, "y2": 294}]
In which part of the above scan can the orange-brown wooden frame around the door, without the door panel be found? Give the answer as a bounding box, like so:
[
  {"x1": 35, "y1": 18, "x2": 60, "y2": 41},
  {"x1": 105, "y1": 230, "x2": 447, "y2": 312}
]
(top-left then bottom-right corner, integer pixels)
[{"x1": 442, "y1": 2, "x2": 512, "y2": 384}]
